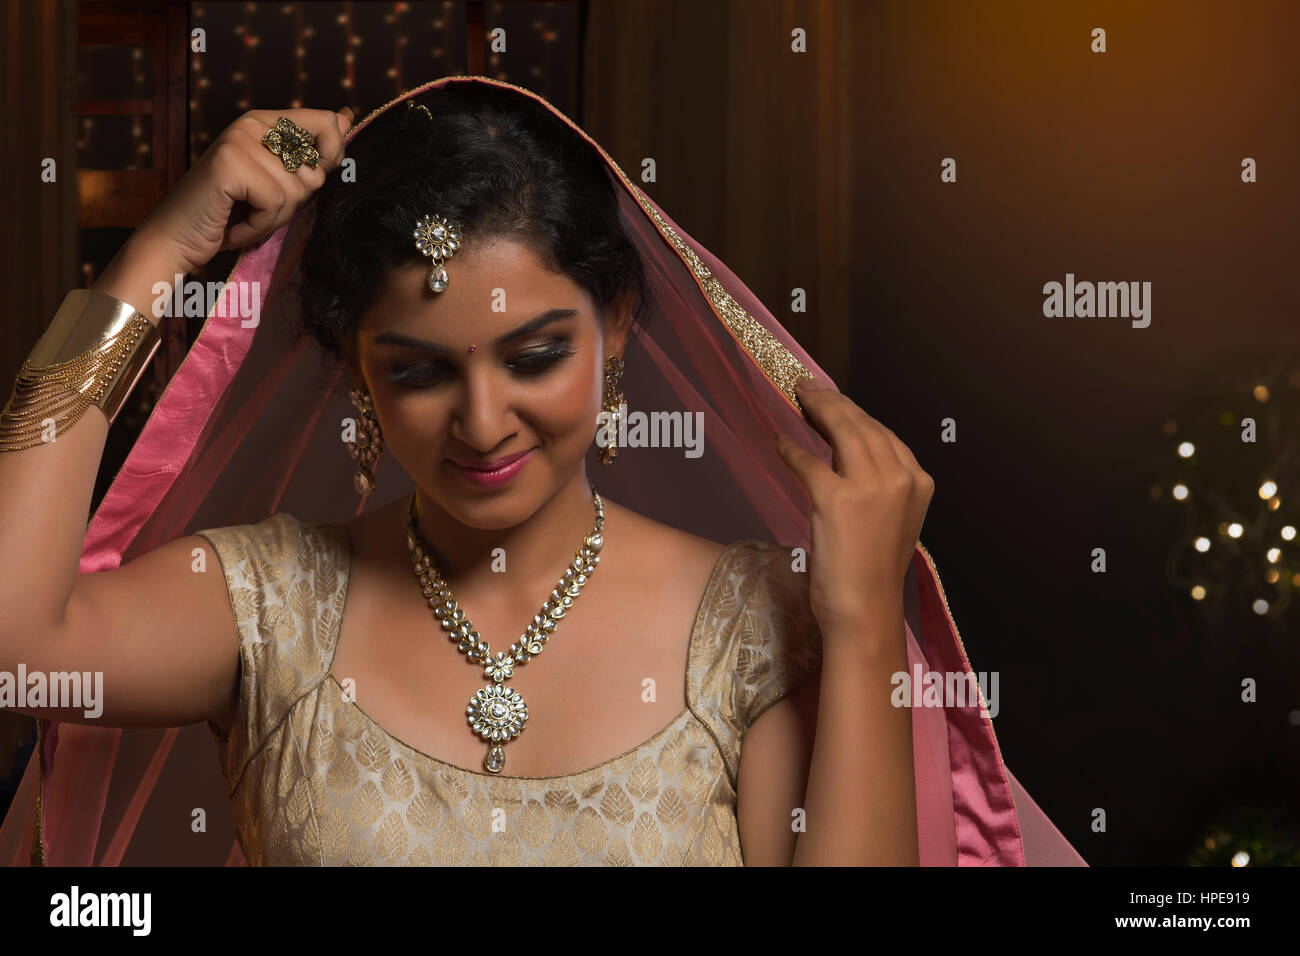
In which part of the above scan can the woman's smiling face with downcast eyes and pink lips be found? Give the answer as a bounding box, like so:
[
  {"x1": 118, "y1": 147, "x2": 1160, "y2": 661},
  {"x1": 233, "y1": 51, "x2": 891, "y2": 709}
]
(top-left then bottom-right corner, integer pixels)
[{"x1": 348, "y1": 239, "x2": 627, "y2": 529}]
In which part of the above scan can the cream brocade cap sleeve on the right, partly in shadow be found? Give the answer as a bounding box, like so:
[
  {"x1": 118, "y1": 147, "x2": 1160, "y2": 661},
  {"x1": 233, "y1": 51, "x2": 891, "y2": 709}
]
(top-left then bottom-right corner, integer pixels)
[{"x1": 690, "y1": 540, "x2": 822, "y2": 786}]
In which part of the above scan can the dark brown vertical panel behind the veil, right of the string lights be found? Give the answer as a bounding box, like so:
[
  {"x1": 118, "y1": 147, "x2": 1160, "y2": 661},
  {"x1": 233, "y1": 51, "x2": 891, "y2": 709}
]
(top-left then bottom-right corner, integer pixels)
[{"x1": 579, "y1": 0, "x2": 852, "y2": 388}]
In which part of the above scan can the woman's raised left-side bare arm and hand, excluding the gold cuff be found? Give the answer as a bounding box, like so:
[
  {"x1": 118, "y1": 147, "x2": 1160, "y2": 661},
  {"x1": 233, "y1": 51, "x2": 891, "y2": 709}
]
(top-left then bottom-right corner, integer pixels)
[{"x1": 0, "y1": 109, "x2": 347, "y2": 726}]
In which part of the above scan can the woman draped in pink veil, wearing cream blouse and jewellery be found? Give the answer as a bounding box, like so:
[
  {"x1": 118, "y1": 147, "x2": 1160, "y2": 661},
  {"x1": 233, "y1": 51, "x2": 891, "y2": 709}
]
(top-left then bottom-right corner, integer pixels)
[{"x1": 0, "y1": 77, "x2": 1082, "y2": 865}]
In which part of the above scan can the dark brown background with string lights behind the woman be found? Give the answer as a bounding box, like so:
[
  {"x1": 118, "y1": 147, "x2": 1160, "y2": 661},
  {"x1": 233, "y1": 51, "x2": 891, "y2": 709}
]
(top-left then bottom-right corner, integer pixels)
[{"x1": 0, "y1": 0, "x2": 1300, "y2": 866}]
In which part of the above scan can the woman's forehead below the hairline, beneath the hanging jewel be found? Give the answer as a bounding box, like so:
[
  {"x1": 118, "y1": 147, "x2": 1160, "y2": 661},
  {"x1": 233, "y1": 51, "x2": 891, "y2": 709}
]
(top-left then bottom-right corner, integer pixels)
[{"x1": 360, "y1": 238, "x2": 593, "y2": 341}]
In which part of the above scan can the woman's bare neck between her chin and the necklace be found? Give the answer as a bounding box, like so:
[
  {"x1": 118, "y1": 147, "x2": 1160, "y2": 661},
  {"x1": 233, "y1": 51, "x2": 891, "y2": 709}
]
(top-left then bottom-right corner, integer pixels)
[{"x1": 402, "y1": 468, "x2": 595, "y2": 587}]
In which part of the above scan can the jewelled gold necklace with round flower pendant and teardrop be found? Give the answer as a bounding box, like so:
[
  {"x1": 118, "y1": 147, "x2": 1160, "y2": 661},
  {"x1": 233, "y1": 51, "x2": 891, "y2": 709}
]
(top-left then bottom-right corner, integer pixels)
[{"x1": 406, "y1": 483, "x2": 605, "y2": 774}]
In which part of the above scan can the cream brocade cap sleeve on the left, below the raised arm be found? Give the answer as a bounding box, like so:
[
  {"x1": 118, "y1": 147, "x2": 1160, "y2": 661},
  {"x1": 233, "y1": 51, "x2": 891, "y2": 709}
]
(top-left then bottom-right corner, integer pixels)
[{"x1": 195, "y1": 511, "x2": 348, "y2": 791}]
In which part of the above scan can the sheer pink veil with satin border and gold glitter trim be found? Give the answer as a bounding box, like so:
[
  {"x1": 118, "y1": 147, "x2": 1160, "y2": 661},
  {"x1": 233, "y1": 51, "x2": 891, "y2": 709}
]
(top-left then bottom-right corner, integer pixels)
[{"x1": 0, "y1": 77, "x2": 1086, "y2": 866}]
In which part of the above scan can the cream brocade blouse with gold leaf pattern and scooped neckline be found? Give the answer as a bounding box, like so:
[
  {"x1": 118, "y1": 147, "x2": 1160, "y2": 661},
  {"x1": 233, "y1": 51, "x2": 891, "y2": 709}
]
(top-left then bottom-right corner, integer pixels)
[{"x1": 198, "y1": 512, "x2": 822, "y2": 866}]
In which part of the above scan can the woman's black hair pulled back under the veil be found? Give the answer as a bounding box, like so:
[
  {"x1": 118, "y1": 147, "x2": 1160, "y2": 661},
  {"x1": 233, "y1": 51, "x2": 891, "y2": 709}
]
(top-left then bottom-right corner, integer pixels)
[{"x1": 299, "y1": 83, "x2": 647, "y2": 369}]
